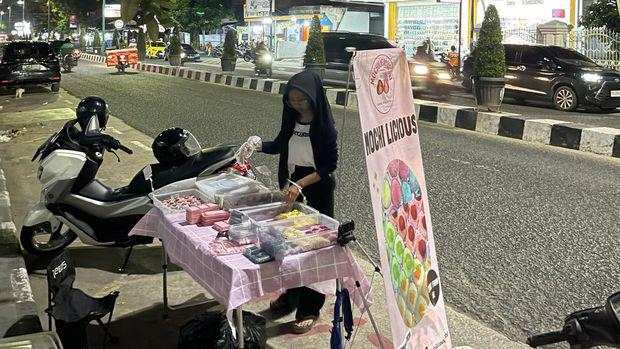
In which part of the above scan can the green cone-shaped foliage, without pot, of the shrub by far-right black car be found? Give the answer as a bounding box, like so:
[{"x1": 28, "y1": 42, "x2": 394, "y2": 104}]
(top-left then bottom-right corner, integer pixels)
[{"x1": 473, "y1": 5, "x2": 506, "y2": 78}]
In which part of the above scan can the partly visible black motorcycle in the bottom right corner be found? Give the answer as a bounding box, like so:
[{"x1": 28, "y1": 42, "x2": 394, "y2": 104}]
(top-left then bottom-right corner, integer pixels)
[{"x1": 527, "y1": 292, "x2": 620, "y2": 349}]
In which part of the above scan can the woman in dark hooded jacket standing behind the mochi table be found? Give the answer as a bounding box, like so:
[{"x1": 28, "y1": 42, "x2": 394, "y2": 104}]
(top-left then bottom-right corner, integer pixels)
[{"x1": 247, "y1": 71, "x2": 338, "y2": 334}]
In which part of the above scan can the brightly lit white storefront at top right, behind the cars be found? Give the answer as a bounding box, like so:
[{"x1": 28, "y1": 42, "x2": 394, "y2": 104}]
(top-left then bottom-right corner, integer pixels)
[{"x1": 385, "y1": 0, "x2": 582, "y2": 56}]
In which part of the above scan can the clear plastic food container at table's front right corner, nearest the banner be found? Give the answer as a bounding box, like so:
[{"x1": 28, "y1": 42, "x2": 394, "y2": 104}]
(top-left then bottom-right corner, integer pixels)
[{"x1": 252, "y1": 214, "x2": 340, "y2": 260}]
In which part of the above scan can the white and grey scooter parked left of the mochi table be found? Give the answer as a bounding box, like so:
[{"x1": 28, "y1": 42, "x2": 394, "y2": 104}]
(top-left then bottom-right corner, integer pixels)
[{"x1": 20, "y1": 113, "x2": 236, "y2": 269}]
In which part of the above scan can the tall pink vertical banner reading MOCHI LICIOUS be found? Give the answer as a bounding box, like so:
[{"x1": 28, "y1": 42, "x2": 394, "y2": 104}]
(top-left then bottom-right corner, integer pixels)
[{"x1": 353, "y1": 48, "x2": 452, "y2": 348}]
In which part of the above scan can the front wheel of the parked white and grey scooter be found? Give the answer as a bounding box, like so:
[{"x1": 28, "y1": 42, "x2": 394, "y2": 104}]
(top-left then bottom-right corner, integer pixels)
[{"x1": 19, "y1": 222, "x2": 77, "y2": 256}]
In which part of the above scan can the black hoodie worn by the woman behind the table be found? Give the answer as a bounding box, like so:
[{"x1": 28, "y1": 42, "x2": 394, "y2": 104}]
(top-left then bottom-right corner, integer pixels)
[{"x1": 262, "y1": 70, "x2": 338, "y2": 188}]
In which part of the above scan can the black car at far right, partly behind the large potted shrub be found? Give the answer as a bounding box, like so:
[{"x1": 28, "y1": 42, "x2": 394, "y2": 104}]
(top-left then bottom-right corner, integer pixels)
[{"x1": 463, "y1": 45, "x2": 620, "y2": 111}]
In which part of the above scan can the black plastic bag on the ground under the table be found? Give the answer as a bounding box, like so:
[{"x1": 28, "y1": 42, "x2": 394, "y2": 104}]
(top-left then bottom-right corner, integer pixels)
[{"x1": 178, "y1": 311, "x2": 267, "y2": 349}]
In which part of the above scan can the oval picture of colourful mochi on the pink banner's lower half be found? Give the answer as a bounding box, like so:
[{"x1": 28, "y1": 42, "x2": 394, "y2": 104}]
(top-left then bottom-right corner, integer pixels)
[{"x1": 380, "y1": 159, "x2": 439, "y2": 328}]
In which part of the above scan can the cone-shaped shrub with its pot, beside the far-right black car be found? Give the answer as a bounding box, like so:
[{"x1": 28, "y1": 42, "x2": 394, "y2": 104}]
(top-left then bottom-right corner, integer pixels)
[{"x1": 472, "y1": 5, "x2": 506, "y2": 112}]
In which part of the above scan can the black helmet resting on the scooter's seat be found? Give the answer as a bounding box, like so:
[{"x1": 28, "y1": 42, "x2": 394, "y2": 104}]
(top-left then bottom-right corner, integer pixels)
[{"x1": 151, "y1": 127, "x2": 202, "y2": 166}]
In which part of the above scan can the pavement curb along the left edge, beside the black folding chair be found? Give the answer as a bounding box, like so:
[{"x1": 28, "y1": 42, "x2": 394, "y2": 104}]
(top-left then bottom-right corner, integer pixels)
[{"x1": 0, "y1": 164, "x2": 43, "y2": 338}]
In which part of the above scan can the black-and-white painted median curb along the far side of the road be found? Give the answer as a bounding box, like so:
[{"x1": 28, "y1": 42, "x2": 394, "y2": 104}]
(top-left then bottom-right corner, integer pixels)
[{"x1": 82, "y1": 54, "x2": 620, "y2": 158}]
